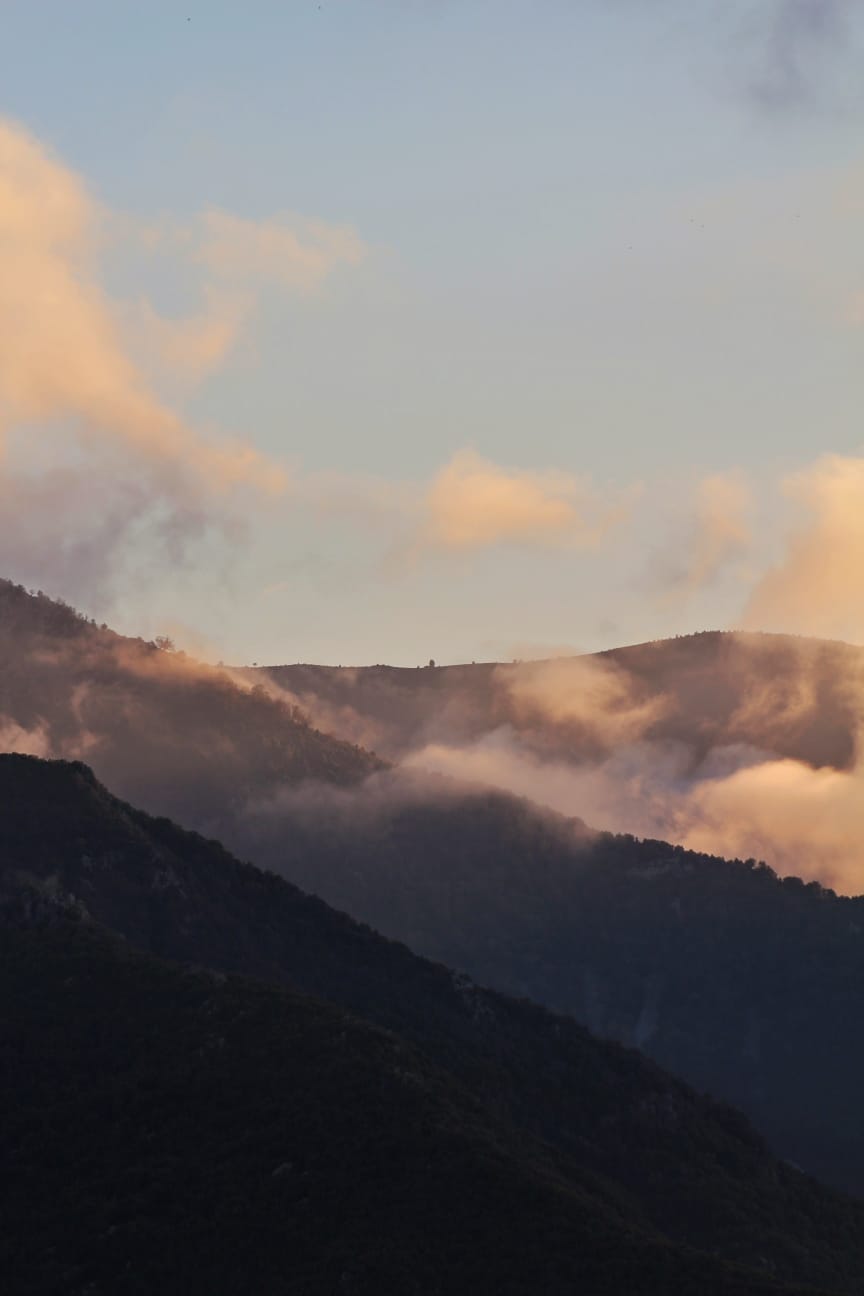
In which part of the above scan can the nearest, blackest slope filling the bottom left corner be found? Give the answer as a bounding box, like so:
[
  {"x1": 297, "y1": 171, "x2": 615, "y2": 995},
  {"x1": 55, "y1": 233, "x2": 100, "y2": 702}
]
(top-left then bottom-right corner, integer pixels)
[{"x1": 0, "y1": 919, "x2": 803, "y2": 1296}]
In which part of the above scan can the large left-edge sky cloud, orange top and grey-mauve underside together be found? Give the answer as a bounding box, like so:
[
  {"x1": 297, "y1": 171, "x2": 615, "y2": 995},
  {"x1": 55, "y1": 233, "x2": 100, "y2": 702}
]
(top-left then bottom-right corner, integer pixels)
[{"x1": 0, "y1": 118, "x2": 363, "y2": 607}]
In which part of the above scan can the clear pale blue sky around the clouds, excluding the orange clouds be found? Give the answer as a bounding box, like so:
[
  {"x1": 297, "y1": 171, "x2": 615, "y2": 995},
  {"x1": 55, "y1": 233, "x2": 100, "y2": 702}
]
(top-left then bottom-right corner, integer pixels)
[{"x1": 0, "y1": 0, "x2": 864, "y2": 664}]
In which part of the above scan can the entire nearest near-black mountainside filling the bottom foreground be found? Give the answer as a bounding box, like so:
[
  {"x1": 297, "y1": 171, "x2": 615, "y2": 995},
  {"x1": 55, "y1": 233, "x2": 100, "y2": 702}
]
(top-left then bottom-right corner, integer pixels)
[{"x1": 0, "y1": 756, "x2": 864, "y2": 1296}]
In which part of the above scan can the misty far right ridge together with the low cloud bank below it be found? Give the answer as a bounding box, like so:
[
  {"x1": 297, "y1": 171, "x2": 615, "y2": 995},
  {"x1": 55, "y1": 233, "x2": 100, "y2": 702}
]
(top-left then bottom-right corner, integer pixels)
[{"x1": 256, "y1": 632, "x2": 864, "y2": 893}]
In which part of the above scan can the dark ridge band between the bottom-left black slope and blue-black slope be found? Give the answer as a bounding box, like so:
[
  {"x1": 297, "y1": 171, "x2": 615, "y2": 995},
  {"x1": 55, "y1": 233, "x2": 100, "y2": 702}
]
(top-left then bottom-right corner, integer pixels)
[{"x1": 0, "y1": 756, "x2": 864, "y2": 1291}]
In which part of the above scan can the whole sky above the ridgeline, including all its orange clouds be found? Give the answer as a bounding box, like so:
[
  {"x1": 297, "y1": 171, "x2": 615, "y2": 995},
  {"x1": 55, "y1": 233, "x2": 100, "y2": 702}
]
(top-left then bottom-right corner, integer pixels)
[{"x1": 0, "y1": 0, "x2": 864, "y2": 665}]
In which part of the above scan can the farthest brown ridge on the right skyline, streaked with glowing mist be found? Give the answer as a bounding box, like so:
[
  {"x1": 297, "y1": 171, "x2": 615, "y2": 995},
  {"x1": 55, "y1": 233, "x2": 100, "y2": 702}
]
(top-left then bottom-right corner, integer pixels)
[{"x1": 259, "y1": 631, "x2": 864, "y2": 769}]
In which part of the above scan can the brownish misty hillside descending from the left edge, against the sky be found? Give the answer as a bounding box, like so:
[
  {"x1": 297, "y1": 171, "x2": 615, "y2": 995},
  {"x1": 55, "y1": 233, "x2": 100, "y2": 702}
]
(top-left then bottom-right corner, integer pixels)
[{"x1": 0, "y1": 581, "x2": 381, "y2": 826}]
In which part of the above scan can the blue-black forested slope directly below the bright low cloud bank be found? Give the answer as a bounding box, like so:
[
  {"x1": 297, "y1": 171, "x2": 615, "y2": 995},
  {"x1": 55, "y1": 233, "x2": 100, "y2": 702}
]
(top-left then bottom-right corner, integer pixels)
[{"x1": 256, "y1": 797, "x2": 864, "y2": 1192}]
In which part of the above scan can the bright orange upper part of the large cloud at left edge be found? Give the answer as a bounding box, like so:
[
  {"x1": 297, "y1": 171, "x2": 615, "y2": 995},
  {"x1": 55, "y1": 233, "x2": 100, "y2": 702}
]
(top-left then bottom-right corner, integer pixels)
[{"x1": 0, "y1": 122, "x2": 284, "y2": 491}]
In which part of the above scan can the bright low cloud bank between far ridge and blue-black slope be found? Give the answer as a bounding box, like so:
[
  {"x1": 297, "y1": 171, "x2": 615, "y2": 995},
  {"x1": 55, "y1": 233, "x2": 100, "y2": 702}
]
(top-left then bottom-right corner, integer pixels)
[{"x1": 404, "y1": 728, "x2": 864, "y2": 894}]
